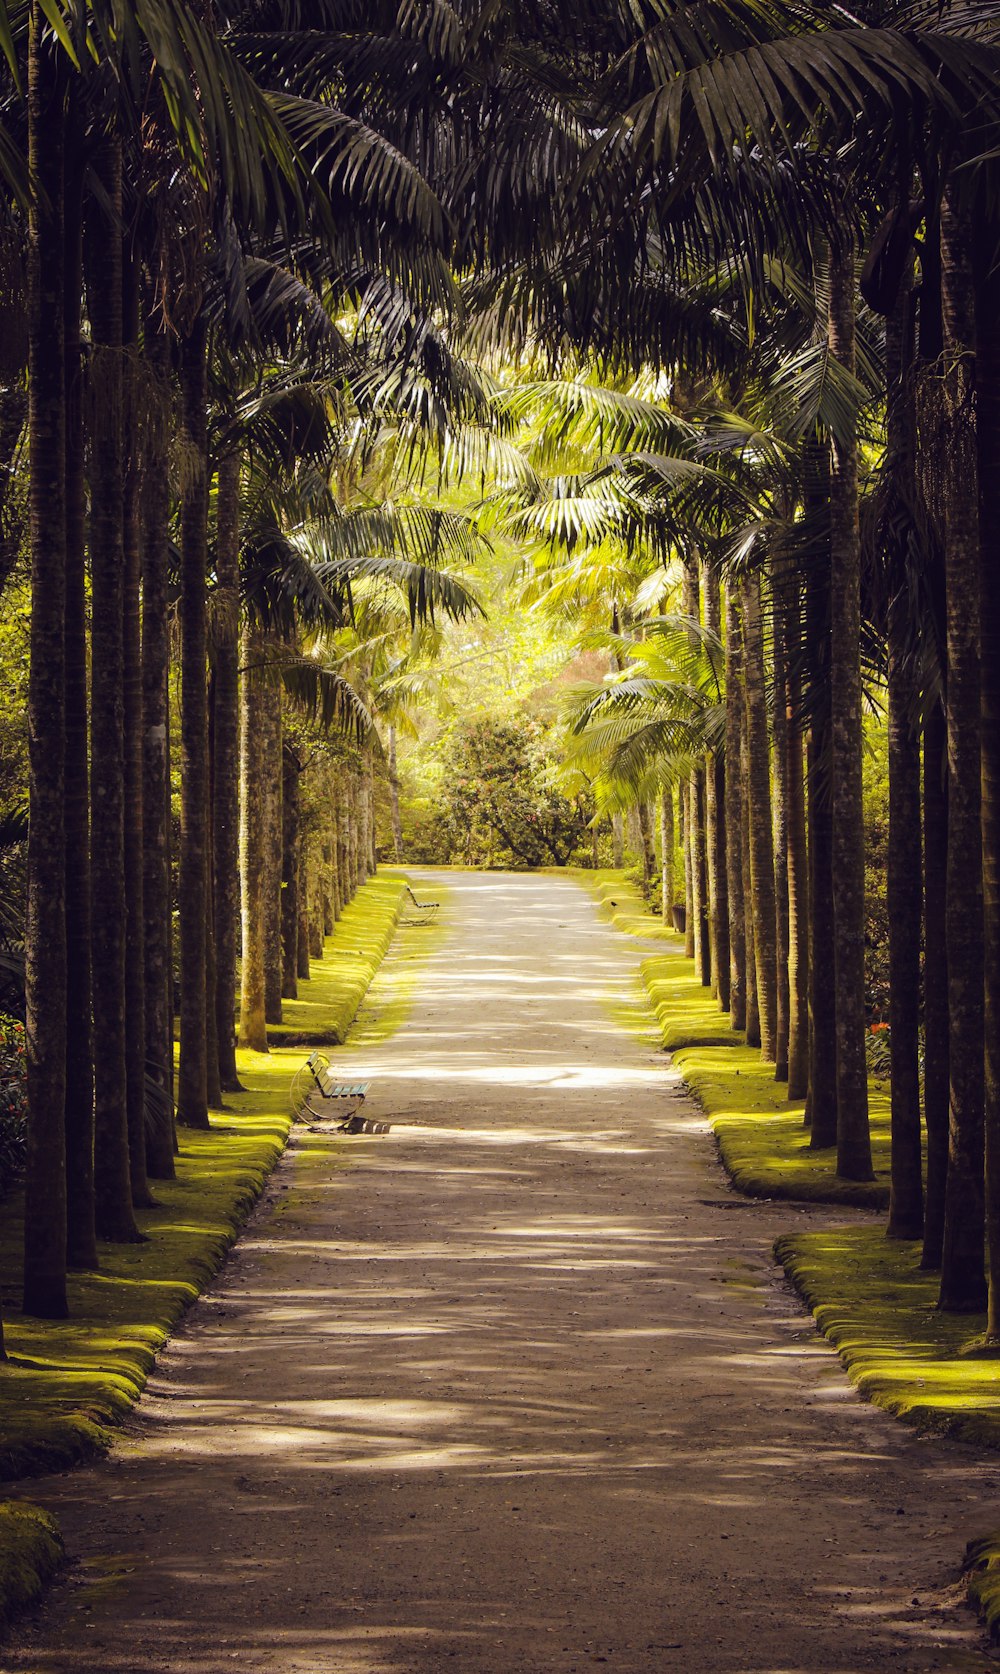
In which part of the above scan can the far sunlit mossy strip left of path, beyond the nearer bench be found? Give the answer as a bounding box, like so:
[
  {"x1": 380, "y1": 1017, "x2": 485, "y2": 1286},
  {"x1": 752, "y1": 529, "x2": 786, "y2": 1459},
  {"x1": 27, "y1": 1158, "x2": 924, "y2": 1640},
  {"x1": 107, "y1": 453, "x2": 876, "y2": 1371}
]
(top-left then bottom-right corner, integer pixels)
[{"x1": 268, "y1": 867, "x2": 409, "y2": 1046}]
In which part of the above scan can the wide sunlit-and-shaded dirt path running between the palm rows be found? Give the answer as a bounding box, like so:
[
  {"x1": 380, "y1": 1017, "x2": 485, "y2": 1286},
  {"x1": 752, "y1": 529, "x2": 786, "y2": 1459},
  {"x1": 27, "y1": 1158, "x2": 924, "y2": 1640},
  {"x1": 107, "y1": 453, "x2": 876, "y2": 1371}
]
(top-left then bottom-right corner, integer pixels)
[{"x1": 2, "y1": 874, "x2": 1000, "y2": 1674}]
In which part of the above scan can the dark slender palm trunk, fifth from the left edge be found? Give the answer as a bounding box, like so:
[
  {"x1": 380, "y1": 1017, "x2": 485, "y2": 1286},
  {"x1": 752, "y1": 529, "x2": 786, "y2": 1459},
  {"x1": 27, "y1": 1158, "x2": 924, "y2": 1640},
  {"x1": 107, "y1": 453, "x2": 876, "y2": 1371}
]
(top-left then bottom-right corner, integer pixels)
[{"x1": 142, "y1": 293, "x2": 174, "y2": 1180}]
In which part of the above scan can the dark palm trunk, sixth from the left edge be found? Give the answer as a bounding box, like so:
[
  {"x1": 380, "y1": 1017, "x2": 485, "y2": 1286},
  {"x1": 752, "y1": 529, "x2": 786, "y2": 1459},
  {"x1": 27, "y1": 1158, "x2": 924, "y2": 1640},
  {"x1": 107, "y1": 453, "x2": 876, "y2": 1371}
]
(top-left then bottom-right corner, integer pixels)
[{"x1": 178, "y1": 316, "x2": 209, "y2": 1128}]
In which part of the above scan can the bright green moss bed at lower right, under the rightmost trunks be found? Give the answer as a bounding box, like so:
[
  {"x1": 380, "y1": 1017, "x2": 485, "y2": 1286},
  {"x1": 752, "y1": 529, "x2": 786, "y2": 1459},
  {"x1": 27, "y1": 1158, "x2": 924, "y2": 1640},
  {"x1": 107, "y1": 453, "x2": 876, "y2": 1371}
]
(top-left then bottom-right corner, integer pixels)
[{"x1": 774, "y1": 1227, "x2": 1000, "y2": 1453}]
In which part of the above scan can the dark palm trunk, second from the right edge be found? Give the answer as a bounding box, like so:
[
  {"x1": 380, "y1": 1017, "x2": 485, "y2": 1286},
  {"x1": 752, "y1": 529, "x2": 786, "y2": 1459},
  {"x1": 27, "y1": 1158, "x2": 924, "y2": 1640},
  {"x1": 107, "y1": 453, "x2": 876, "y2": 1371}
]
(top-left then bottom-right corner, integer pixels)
[{"x1": 940, "y1": 201, "x2": 987, "y2": 1312}]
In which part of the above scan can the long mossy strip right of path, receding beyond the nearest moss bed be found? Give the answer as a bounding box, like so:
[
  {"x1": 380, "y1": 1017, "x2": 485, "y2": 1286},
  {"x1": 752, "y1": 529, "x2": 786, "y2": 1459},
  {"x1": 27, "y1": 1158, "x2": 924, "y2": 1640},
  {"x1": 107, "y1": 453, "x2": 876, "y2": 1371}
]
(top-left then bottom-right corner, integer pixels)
[{"x1": 578, "y1": 872, "x2": 889, "y2": 1209}]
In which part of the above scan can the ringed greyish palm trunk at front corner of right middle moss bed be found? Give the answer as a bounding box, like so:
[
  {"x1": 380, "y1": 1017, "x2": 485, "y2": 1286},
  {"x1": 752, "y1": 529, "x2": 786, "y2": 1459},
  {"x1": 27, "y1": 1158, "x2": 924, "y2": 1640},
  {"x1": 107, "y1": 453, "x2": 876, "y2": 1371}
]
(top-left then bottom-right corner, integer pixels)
[{"x1": 829, "y1": 238, "x2": 874, "y2": 1180}]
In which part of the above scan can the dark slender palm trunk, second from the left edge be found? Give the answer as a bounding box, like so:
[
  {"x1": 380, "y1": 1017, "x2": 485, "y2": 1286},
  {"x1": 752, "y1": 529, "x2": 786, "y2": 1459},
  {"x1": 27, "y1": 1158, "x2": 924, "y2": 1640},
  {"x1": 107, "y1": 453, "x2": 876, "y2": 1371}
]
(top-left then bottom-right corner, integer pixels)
[{"x1": 64, "y1": 118, "x2": 97, "y2": 1267}]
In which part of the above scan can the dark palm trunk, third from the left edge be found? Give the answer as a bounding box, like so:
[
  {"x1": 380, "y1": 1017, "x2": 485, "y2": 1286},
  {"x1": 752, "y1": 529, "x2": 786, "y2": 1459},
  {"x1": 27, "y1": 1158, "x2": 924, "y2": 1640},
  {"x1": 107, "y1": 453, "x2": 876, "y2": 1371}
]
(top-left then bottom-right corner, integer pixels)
[{"x1": 87, "y1": 141, "x2": 139, "y2": 1242}]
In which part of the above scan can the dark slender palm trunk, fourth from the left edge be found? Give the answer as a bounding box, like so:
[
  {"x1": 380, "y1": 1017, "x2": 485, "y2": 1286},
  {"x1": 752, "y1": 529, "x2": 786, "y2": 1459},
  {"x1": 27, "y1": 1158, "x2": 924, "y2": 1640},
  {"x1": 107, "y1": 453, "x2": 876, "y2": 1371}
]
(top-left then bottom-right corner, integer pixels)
[{"x1": 122, "y1": 261, "x2": 154, "y2": 1207}]
